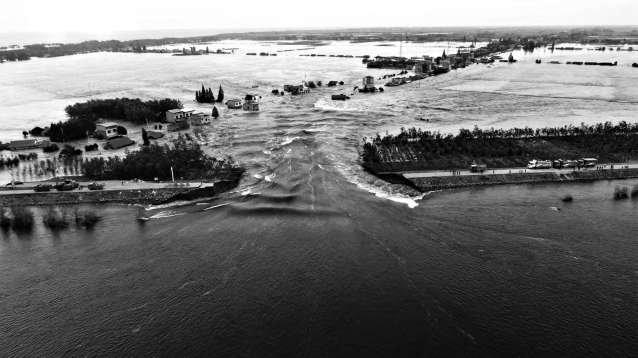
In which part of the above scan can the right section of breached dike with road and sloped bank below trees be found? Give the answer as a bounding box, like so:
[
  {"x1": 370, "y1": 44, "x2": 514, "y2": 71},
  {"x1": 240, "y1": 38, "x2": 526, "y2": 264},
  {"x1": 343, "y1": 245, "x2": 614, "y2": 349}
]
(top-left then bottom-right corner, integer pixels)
[{"x1": 408, "y1": 169, "x2": 638, "y2": 192}]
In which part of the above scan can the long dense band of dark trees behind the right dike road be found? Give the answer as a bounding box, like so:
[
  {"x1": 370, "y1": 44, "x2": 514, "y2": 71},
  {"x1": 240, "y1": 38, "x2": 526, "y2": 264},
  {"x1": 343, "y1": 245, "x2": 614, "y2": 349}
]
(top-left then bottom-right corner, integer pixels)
[{"x1": 361, "y1": 122, "x2": 638, "y2": 170}]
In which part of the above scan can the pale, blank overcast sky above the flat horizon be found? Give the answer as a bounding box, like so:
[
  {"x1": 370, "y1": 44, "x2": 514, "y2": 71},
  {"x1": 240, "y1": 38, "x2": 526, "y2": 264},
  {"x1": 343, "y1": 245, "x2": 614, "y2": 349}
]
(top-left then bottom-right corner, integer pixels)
[{"x1": 0, "y1": 0, "x2": 638, "y2": 33}]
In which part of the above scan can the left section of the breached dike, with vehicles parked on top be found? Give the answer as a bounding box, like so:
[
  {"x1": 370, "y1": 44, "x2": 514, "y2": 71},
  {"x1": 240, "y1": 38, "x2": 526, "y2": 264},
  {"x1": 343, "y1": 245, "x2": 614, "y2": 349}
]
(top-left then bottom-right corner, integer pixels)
[{"x1": 0, "y1": 180, "x2": 239, "y2": 206}]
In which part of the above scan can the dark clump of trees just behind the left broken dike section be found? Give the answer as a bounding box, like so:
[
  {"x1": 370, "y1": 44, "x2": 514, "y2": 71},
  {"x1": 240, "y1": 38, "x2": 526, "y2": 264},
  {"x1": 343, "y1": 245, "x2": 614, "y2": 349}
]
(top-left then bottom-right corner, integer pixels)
[{"x1": 82, "y1": 135, "x2": 241, "y2": 180}]
